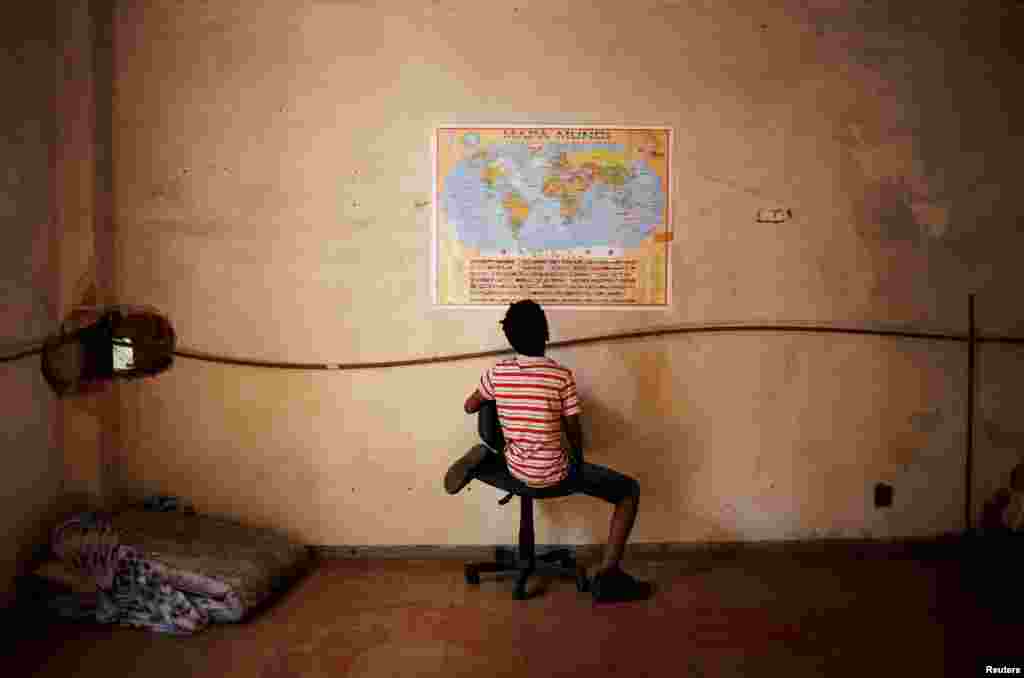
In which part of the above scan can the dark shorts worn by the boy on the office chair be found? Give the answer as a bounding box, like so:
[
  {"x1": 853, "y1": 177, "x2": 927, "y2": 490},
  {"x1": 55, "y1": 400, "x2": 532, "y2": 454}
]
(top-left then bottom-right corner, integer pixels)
[{"x1": 473, "y1": 448, "x2": 640, "y2": 504}]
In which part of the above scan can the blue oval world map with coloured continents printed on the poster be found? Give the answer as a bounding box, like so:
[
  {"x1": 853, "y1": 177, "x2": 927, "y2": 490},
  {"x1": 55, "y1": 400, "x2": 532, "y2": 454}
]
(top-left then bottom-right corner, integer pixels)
[{"x1": 443, "y1": 132, "x2": 667, "y2": 252}]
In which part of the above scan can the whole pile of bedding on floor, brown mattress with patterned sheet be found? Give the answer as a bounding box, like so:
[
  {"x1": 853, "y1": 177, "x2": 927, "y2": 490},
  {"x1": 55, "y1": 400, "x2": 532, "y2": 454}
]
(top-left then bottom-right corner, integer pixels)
[{"x1": 29, "y1": 510, "x2": 309, "y2": 635}]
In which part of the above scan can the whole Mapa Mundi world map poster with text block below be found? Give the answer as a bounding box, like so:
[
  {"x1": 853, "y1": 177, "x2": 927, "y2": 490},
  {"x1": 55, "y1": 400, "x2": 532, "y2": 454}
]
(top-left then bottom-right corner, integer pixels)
[{"x1": 431, "y1": 126, "x2": 672, "y2": 308}]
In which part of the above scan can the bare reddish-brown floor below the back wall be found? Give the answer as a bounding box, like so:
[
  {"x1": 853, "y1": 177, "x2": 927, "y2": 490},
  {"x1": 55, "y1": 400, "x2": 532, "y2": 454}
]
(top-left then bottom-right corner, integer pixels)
[{"x1": 4, "y1": 554, "x2": 1024, "y2": 678}]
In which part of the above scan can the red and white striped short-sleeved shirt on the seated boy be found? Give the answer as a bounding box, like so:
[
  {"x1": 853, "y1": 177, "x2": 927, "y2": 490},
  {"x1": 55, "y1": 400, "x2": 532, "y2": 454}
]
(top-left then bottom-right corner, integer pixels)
[{"x1": 480, "y1": 354, "x2": 583, "y2": 488}]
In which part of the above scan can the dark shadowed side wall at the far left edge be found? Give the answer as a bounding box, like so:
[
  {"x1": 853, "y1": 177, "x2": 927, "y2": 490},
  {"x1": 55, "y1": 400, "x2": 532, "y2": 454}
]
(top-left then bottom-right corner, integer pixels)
[{"x1": 0, "y1": 6, "x2": 62, "y2": 606}]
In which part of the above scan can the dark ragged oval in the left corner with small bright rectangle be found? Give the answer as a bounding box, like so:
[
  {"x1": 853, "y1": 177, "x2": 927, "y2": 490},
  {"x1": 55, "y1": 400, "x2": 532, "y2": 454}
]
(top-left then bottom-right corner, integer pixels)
[{"x1": 42, "y1": 305, "x2": 176, "y2": 397}]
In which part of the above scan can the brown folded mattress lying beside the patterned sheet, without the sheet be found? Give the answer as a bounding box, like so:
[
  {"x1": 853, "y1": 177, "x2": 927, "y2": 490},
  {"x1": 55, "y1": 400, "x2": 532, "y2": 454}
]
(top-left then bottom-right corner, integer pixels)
[{"x1": 112, "y1": 509, "x2": 310, "y2": 615}]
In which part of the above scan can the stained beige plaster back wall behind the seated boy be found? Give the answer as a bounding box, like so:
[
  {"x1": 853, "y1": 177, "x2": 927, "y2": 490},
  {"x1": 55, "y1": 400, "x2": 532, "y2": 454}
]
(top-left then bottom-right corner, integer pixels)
[{"x1": 110, "y1": 0, "x2": 1024, "y2": 545}]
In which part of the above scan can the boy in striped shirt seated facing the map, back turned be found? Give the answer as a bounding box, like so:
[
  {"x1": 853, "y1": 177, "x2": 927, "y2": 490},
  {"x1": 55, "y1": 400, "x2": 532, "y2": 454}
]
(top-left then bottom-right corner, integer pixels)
[{"x1": 444, "y1": 299, "x2": 651, "y2": 602}]
